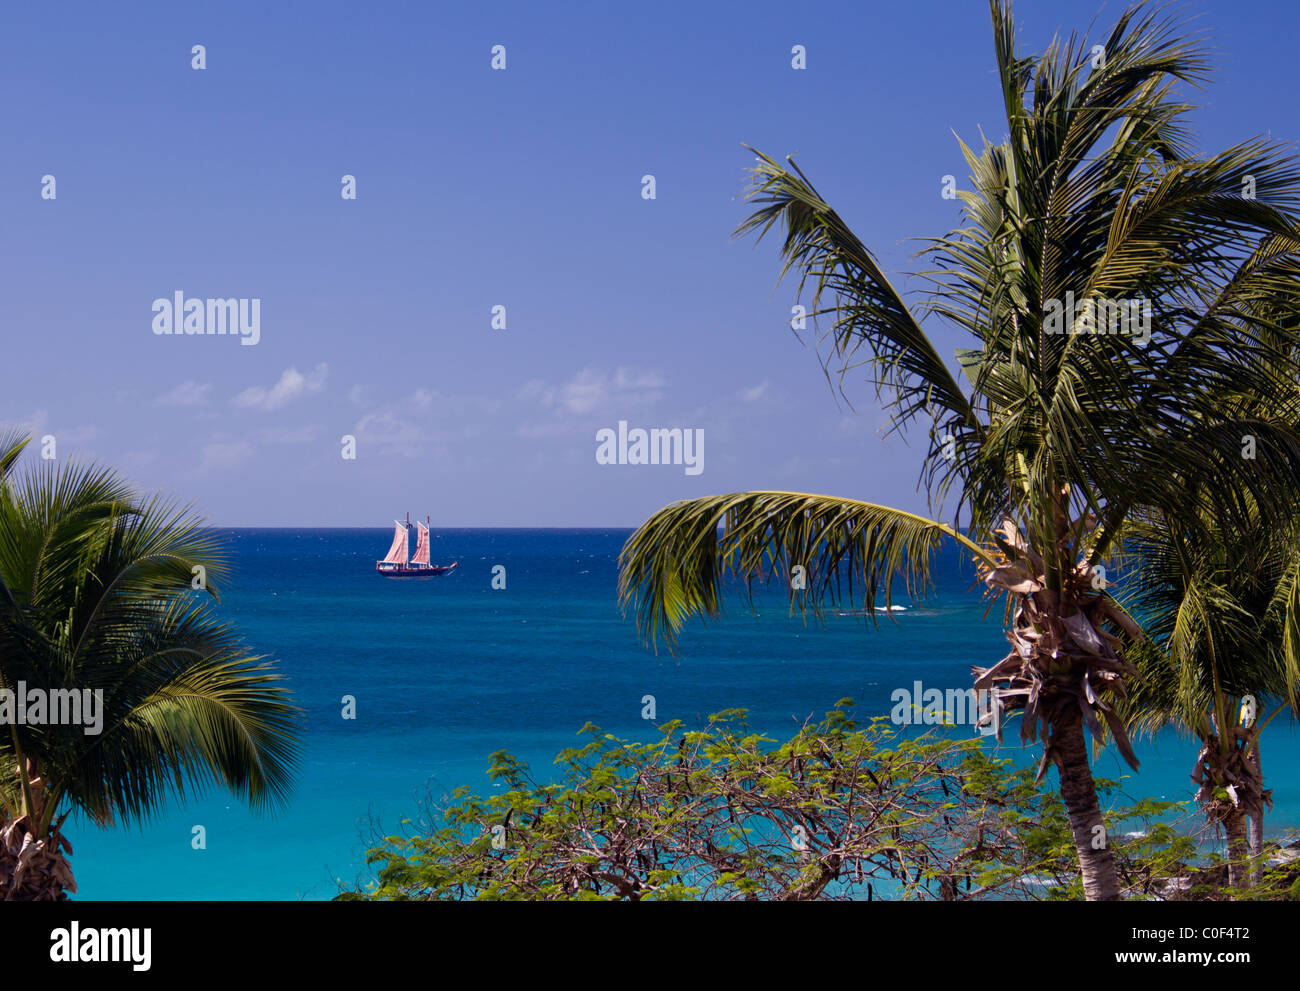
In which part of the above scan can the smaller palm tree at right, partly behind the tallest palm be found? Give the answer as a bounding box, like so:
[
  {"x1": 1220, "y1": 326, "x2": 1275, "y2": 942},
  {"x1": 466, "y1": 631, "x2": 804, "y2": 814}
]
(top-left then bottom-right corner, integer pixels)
[{"x1": 1121, "y1": 486, "x2": 1300, "y2": 887}]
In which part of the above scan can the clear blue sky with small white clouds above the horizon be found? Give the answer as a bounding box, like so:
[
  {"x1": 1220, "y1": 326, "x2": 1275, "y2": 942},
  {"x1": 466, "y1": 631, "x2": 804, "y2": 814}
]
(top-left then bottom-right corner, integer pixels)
[{"x1": 0, "y1": 0, "x2": 1300, "y2": 527}]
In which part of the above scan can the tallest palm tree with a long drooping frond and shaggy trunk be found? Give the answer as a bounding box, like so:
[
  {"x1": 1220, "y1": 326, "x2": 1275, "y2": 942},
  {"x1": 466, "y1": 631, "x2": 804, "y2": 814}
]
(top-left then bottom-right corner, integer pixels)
[{"x1": 620, "y1": 0, "x2": 1300, "y2": 900}]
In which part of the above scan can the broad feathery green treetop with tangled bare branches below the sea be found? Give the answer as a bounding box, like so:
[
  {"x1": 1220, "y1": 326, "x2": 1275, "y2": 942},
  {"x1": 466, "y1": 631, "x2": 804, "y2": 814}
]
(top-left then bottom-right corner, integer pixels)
[{"x1": 339, "y1": 700, "x2": 1227, "y2": 901}]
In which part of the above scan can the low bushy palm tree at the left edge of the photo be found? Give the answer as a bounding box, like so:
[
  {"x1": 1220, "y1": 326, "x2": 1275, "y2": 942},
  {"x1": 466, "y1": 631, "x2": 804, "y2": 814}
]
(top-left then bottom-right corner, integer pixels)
[{"x1": 0, "y1": 434, "x2": 298, "y2": 900}]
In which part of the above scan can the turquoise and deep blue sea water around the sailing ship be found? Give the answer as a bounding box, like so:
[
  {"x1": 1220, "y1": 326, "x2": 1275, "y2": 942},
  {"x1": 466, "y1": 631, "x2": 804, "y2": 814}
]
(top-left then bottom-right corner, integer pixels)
[{"x1": 68, "y1": 529, "x2": 1300, "y2": 900}]
